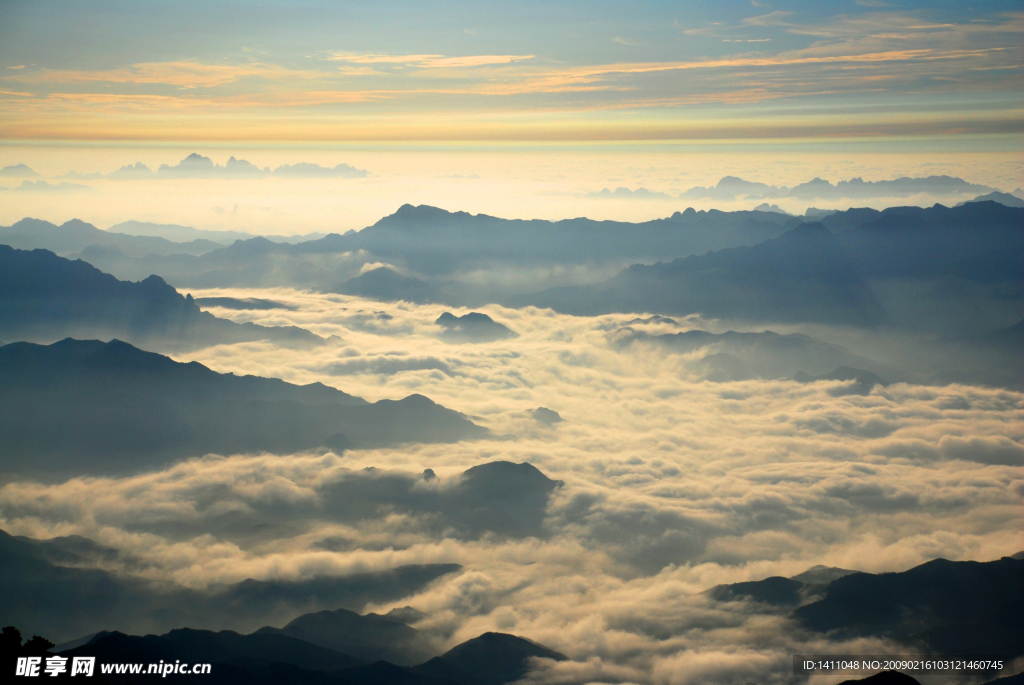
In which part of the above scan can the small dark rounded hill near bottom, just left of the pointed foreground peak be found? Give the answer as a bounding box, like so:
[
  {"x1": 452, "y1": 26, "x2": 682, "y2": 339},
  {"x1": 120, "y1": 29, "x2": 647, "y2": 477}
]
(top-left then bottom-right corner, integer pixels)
[{"x1": 256, "y1": 609, "x2": 437, "y2": 666}]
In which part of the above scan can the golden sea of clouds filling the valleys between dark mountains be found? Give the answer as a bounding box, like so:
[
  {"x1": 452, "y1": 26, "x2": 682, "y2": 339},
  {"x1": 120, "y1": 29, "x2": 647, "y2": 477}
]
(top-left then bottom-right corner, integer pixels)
[{"x1": 0, "y1": 290, "x2": 1024, "y2": 685}]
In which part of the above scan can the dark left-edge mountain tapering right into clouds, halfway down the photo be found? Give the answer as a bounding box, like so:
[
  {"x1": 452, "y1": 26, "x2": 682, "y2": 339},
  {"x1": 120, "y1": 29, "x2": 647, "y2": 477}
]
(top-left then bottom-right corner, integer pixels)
[{"x1": 0, "y1": 339, "x2": 486, "y2": 473}]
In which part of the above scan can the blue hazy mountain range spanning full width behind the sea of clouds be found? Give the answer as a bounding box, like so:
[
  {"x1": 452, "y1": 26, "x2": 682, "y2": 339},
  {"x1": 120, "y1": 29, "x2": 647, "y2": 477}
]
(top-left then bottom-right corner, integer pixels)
[{"x1": 0, "y1": 201, "x2": 1024, "y2": 334}]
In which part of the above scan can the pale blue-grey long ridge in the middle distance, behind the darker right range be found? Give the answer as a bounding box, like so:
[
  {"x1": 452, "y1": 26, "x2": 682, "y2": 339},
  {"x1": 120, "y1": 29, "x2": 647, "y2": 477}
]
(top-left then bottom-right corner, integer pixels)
[{"x1": 56, "y1": 205, "x2": 799, "y2": 288}]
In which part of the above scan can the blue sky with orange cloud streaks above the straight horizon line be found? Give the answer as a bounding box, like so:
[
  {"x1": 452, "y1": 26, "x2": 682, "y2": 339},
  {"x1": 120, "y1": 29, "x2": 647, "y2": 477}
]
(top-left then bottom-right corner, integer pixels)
[{"x1": 0, "y1": 0, "x2": 1024, "y2": 142}]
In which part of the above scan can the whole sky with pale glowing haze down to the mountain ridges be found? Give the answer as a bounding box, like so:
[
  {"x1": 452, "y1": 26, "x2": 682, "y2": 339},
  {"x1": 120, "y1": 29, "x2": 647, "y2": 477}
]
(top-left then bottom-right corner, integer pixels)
[{"x1": 0, "y1": 0, "x2": 1024, "y2": 233}]
